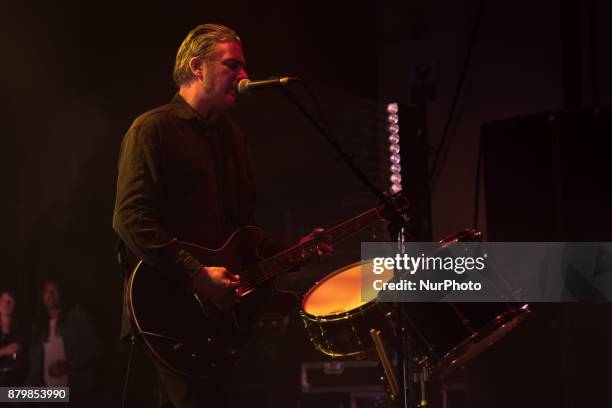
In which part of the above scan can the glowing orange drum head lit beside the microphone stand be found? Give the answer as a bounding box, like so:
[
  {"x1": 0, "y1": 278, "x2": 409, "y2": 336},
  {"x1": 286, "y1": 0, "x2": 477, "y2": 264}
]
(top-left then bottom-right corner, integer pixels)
[{"x1": 302, "y1": 260, "x2": 393, "y2": 316}]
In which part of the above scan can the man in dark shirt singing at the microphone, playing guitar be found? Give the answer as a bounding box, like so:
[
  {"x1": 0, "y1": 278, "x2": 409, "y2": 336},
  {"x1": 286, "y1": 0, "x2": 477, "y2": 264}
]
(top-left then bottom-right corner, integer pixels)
[{"x1": 113, "y1": 24, "x2": 326, "y2": 407}]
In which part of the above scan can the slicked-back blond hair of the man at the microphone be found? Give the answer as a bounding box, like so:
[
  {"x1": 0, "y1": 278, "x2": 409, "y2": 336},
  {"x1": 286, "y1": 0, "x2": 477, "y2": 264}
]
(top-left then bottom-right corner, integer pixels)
[{"x1": 172, "y1": 24, "x2": 240, "y2": 88}]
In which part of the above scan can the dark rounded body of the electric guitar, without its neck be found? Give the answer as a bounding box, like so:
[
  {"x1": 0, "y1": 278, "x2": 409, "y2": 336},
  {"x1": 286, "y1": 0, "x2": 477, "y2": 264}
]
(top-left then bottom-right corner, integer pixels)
[{"x1": 127, "y1": 226, "x2": 272, "y2": 378}]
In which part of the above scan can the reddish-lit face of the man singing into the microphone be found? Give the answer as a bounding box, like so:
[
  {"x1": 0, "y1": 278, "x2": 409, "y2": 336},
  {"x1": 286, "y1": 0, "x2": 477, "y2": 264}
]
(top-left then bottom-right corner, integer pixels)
[{"x1": 203, "y1": 41, "x2": 249, "y2": 110}]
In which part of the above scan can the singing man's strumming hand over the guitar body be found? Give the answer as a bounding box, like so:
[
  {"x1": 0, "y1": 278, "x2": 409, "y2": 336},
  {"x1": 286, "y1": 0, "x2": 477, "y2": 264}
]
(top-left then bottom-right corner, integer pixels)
[{"x1": 191, "y1": 266, "x2": 240, "y2": 310}]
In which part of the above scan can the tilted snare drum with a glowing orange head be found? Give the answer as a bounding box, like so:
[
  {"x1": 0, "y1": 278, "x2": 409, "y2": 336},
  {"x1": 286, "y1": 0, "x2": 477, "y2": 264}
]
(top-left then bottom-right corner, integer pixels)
[{"x1": 300, "y1": 261, "x2": 393, "y2": 359}]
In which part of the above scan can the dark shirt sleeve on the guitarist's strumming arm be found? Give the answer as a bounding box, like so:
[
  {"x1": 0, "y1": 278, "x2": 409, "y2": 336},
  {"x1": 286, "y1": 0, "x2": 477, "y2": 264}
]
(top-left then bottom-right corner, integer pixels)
[{"x1": 113, "y1": 117, "x2": 202, "y2": 278}]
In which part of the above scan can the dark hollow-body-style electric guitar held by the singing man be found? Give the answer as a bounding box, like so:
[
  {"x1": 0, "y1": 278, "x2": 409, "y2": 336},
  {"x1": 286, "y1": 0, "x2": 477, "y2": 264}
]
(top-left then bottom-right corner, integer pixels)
[{"x1": 127, "y1": 194, "x2": 408, "y2": 379}]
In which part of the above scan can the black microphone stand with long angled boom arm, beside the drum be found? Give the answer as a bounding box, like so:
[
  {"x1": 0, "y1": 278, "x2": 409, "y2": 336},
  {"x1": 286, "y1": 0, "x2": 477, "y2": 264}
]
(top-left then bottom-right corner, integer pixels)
[{"x1": 282, "y1": 81, "x2": 416, "y2": 408}]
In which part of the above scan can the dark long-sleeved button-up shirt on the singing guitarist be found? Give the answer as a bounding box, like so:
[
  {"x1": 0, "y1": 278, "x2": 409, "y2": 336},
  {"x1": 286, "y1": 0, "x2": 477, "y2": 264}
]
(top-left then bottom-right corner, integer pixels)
[{"x1": 113, "y1": 94, "x2": 255, "y2": 277}]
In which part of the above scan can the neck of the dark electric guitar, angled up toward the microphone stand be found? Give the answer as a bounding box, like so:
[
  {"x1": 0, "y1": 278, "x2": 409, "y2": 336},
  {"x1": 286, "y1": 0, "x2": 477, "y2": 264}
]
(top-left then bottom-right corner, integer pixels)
[{"x1": 243, "y1": 208, "x2": 381, "y2": 288}]
